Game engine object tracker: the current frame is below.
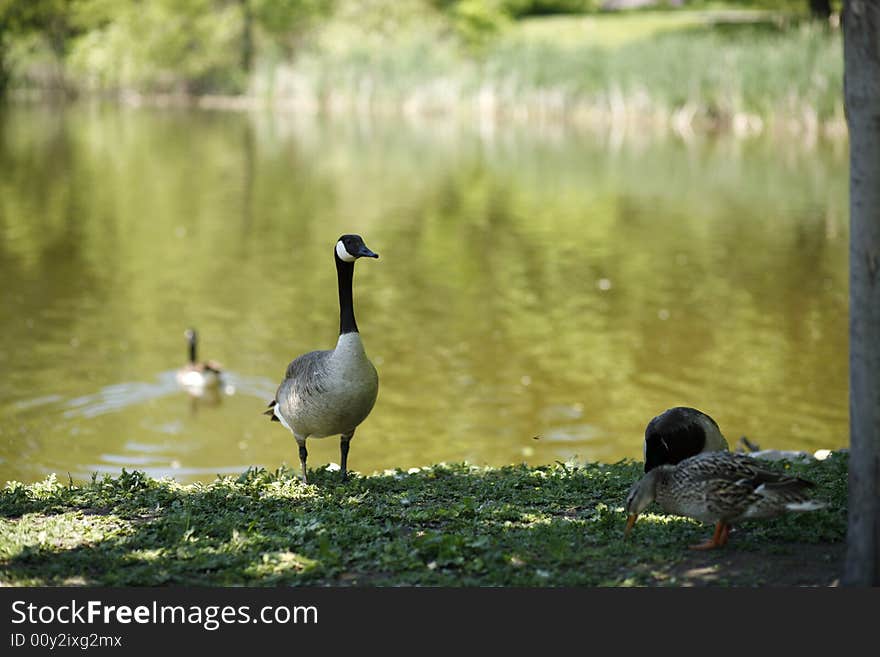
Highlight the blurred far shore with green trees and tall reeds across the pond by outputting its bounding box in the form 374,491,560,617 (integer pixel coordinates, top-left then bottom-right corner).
0,0,843,132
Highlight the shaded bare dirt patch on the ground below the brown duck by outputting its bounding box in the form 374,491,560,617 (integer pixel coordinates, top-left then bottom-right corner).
655,543,846,586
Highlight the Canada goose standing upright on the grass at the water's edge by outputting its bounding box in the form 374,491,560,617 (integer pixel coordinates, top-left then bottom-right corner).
265,235,379,483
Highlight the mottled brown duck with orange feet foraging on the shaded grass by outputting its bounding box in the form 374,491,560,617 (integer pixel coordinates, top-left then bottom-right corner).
625,452,825,550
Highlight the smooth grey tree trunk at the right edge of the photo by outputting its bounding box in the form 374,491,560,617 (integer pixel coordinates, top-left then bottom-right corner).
842,0,880,586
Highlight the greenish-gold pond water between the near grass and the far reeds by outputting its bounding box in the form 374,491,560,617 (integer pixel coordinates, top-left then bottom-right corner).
0,104,848,483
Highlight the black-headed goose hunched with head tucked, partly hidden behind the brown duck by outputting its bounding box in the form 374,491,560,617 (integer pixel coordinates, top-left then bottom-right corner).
644,406,728,472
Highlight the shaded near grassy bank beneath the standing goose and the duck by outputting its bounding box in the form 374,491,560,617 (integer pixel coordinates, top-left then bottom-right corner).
0,455,847,586
